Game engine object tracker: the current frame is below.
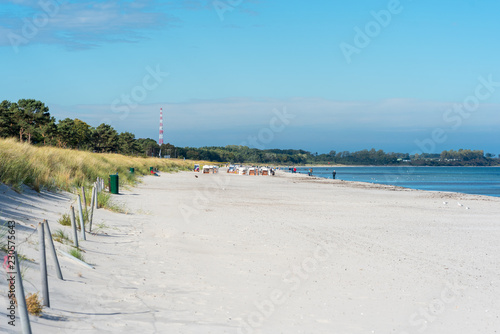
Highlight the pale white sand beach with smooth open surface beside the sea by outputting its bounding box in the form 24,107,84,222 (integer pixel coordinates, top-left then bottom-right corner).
0,169,500,334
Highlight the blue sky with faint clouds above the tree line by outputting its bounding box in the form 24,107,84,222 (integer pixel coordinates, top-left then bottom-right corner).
0,0,500,154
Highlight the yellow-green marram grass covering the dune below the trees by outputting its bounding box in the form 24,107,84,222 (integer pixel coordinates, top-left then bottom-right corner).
0,138,193,191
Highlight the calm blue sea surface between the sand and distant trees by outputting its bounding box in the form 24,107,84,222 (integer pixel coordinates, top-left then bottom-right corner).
288,167,500,197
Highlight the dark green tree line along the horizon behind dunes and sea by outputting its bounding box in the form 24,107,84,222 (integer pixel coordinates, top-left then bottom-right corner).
0,99,500,166
